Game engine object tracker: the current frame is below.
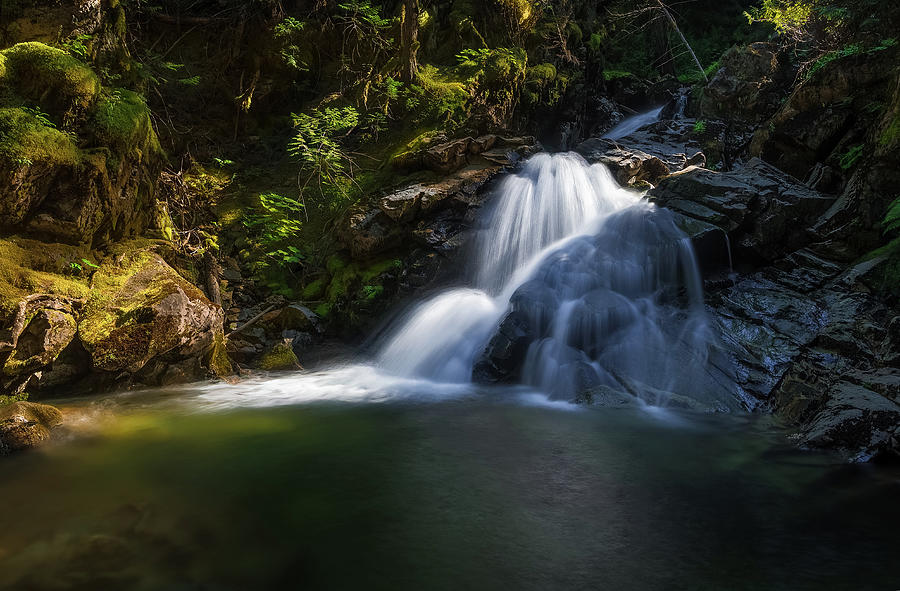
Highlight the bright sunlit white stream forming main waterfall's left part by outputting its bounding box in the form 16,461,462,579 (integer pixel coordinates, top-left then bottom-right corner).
377,153,641,382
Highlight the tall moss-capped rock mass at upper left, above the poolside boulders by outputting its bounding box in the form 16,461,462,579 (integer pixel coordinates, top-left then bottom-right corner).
0,43,164,246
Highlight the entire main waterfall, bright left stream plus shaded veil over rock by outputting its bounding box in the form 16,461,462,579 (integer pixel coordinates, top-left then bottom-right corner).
376,147,735,408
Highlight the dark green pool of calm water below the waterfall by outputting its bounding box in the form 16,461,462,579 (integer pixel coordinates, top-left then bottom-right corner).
0,393,900,591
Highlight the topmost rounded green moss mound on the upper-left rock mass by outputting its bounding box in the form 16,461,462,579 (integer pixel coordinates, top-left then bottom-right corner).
0,42,101,125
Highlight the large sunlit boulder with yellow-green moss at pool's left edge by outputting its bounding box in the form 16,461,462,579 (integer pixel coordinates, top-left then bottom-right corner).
78,249,230,383
